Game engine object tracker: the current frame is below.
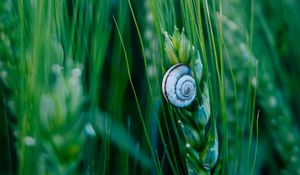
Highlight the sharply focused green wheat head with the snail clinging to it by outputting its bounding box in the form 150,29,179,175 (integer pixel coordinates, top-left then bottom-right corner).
164,28,219,174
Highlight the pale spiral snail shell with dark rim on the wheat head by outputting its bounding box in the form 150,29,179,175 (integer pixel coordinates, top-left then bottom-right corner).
162,64,196,107
